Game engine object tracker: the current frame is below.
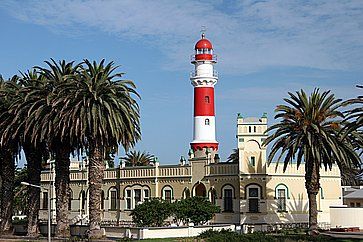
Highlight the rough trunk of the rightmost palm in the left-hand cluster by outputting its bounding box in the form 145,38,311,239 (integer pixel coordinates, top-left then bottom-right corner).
88,144,105,239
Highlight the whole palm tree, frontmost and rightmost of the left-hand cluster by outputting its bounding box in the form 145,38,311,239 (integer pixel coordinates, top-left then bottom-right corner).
57,60,140,238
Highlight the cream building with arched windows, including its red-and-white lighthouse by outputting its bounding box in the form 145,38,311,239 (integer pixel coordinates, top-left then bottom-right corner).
40,34,342,229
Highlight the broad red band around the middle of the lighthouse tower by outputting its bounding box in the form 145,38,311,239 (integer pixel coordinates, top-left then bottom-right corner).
194,87,214,117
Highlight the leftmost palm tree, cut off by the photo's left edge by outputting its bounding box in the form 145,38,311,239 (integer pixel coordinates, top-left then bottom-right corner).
0,75,19,233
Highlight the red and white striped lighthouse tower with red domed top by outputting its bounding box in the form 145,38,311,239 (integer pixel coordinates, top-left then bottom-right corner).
190,33,218,152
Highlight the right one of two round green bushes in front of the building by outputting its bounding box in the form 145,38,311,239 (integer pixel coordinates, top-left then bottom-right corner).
173,197,220,224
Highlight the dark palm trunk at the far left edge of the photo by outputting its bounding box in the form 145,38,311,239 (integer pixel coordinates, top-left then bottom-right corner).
0,147,15,234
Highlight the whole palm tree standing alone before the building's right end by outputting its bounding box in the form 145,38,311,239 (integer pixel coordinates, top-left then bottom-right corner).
264,89,360,233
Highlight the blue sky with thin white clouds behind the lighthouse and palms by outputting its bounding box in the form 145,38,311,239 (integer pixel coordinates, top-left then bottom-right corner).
0,0,363,164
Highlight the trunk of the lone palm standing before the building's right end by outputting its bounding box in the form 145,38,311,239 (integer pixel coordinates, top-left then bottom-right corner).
305,162,320,235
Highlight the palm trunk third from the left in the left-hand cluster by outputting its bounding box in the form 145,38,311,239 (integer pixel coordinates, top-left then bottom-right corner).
54,144,71,238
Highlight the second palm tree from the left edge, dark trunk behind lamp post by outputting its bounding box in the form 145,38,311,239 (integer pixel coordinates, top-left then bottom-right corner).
4,70,48,236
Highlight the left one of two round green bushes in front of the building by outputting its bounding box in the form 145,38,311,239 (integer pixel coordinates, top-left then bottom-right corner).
131,198,172,227
